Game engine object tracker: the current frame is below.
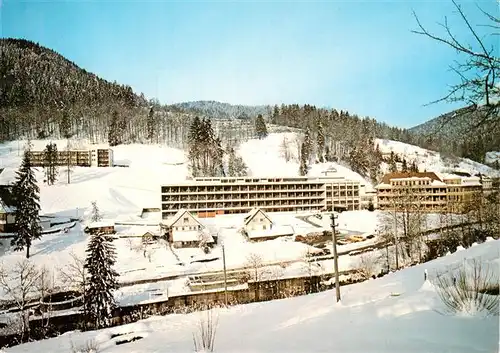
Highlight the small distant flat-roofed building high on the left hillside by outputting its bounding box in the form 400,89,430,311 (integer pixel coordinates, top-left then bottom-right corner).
31,148,113,167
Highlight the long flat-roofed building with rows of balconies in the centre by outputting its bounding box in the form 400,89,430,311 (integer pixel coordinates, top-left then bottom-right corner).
161,177,360,219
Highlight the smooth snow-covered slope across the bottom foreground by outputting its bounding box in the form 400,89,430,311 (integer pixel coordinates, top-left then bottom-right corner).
6,240,500,353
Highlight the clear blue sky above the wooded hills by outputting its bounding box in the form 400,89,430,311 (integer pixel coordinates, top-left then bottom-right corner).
0,0,499,127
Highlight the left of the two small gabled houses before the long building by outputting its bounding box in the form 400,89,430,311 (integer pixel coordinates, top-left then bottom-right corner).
161,209,214,248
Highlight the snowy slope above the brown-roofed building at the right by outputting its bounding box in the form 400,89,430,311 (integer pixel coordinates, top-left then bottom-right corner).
375,139,500,177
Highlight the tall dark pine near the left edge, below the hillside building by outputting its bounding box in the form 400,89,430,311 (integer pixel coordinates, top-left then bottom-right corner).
11,144,42,258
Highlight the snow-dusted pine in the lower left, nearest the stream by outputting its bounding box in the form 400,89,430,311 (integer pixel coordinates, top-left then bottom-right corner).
84,233,118,329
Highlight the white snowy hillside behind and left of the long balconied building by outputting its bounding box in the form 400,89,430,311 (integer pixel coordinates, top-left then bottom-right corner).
0,133,366,218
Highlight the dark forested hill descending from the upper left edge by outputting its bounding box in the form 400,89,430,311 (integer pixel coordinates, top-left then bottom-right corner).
0,38,200,145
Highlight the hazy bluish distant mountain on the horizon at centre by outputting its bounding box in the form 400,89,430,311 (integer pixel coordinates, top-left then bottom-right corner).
172,101,272,119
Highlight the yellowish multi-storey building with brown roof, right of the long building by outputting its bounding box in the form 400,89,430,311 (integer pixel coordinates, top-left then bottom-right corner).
376,172,483,212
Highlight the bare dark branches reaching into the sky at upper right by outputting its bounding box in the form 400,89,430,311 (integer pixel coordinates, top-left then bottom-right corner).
413,0,500,127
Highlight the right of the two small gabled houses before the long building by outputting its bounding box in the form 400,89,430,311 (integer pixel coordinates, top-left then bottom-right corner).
242,208,294,241
